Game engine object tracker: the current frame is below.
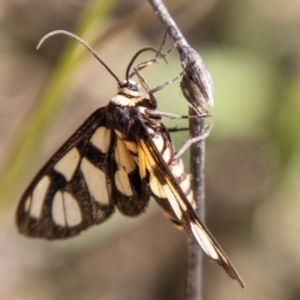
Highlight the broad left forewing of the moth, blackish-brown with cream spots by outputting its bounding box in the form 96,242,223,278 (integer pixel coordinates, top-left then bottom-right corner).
16,108,114,239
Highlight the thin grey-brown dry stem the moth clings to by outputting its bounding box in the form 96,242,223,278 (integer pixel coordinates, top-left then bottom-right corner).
149,0,209,300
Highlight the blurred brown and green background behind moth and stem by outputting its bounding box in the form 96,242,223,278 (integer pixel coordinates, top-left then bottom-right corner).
0,0,300,300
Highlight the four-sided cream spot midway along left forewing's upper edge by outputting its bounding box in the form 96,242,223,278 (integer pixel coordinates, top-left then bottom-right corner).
54,148,80,181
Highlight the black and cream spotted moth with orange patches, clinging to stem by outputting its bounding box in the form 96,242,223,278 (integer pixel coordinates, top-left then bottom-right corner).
16,31,245,287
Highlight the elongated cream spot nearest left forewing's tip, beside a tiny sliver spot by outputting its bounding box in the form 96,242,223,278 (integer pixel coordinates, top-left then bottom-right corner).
29,176,50,219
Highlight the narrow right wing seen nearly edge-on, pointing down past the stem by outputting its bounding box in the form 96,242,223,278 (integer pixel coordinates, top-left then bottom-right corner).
135,122,245,287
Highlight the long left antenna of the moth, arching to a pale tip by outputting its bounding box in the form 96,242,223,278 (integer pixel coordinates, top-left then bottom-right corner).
36,30,124,86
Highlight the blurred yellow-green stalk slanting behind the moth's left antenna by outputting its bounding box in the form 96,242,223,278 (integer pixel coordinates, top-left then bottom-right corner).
0,0,113,210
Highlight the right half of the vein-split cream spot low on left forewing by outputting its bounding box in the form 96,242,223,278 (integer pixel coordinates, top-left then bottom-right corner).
63,192,82,227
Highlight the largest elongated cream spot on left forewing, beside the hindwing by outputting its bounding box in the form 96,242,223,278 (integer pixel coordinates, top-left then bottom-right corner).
80,158,109,205
